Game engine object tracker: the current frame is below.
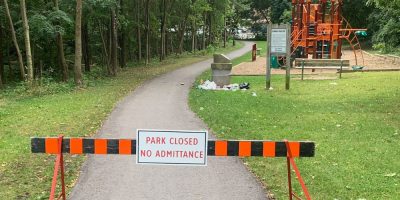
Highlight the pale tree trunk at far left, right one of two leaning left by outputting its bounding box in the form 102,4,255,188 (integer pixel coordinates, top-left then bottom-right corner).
20,0,33,83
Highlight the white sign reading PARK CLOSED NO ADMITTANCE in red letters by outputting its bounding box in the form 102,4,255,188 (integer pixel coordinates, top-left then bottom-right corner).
136,130,208,166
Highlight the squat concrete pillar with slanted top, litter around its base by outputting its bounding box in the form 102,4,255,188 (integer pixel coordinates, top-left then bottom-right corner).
211,54,232,87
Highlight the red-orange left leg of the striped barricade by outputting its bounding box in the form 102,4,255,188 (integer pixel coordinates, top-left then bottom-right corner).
49,135,66,200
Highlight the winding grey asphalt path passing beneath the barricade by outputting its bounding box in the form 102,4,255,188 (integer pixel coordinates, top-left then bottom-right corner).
69,42,266,200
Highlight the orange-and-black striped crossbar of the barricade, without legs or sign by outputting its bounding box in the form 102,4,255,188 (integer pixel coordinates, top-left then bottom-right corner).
31,138,315,157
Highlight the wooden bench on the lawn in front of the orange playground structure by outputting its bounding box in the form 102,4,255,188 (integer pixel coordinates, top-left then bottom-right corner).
295,58,350,80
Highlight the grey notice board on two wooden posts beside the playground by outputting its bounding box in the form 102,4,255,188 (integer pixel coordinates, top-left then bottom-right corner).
265,24,291,90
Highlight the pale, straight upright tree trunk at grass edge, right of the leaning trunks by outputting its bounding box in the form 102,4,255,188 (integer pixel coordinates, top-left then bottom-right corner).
74,0,82,86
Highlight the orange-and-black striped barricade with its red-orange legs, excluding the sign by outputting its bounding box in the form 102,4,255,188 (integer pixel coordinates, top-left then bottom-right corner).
31,136,315,200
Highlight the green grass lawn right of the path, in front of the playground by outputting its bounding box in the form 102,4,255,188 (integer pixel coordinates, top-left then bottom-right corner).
190,59,400,199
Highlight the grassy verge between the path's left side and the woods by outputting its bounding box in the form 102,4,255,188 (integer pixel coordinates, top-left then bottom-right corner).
0,43,242,199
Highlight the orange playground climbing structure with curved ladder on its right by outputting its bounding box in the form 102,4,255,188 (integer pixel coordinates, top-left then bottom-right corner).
291,0,366,65
